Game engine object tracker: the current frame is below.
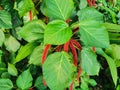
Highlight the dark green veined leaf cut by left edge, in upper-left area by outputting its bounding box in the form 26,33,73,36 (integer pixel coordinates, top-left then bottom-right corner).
0,10,12,29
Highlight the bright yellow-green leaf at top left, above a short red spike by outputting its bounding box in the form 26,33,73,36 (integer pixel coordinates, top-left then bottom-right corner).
16,0,34,17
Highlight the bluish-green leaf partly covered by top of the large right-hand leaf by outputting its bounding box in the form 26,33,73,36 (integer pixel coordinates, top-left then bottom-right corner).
77,7,103,22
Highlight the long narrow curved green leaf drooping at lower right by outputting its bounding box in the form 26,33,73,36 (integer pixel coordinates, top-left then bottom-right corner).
97,48,118,85
